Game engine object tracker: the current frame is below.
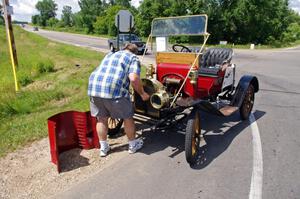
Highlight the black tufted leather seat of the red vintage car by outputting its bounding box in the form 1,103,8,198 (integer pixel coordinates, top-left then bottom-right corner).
200,48,233,68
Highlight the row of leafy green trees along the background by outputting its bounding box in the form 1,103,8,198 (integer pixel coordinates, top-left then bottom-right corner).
32,0,300,44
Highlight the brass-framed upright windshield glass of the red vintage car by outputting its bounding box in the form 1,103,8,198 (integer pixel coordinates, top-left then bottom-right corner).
151,15,207,37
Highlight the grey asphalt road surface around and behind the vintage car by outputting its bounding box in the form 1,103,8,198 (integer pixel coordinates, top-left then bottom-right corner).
25,26,300,199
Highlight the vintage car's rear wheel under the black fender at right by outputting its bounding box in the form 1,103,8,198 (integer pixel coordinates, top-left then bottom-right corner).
240,84,254,120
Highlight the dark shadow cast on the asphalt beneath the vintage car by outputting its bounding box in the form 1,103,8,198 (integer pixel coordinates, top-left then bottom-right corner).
134,111,266,169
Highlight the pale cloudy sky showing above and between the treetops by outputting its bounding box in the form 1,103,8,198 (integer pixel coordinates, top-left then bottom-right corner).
3,0,300,22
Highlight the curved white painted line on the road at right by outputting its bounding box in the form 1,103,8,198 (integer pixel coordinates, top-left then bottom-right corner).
249,113,263,199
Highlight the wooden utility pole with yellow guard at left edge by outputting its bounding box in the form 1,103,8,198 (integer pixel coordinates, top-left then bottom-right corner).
2,0,19,92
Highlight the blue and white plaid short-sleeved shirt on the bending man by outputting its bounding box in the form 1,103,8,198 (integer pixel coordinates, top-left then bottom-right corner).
88,50,141,99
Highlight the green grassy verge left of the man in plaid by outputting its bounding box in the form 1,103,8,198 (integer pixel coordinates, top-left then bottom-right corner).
0,26,103,157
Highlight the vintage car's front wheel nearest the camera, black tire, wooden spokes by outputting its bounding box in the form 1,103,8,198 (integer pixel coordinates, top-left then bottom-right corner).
185,109,201,165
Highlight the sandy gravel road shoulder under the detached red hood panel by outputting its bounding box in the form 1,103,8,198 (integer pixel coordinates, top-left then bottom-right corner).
0,131,128,198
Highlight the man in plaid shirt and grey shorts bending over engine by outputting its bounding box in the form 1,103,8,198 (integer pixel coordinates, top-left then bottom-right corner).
88,43,149,157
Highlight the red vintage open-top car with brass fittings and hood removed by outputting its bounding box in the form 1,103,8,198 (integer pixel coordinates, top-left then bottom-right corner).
110,15,259,164
